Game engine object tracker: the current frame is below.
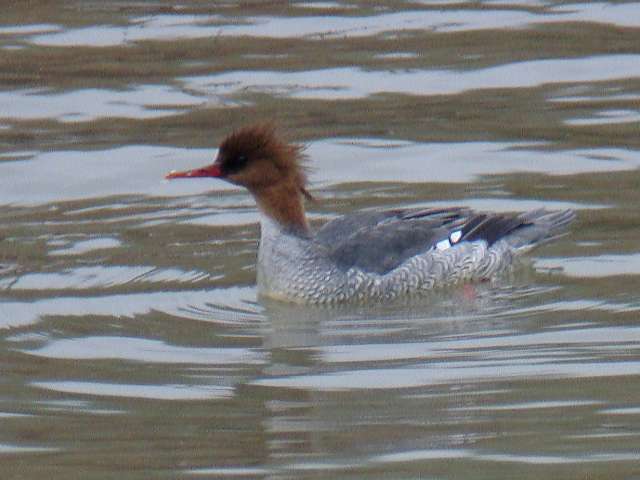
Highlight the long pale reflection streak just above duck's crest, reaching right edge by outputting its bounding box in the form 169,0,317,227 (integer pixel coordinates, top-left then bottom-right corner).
182,55,640,99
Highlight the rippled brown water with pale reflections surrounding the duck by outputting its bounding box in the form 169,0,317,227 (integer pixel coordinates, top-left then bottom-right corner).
0,0,640,480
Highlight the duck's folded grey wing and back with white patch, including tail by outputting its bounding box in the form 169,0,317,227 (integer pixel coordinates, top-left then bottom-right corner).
316,207,575,274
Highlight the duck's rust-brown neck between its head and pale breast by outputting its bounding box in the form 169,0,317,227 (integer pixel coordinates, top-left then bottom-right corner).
253,182,310,237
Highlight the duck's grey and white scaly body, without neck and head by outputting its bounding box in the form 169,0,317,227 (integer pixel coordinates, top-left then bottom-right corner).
257,208,574,304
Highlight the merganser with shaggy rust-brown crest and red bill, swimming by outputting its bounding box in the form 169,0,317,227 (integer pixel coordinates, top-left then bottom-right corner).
166,124,575,304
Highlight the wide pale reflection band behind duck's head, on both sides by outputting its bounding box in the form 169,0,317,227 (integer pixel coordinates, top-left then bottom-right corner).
0,138,640,206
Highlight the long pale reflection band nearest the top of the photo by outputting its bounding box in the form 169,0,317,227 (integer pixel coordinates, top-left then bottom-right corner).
25,1,640,47
